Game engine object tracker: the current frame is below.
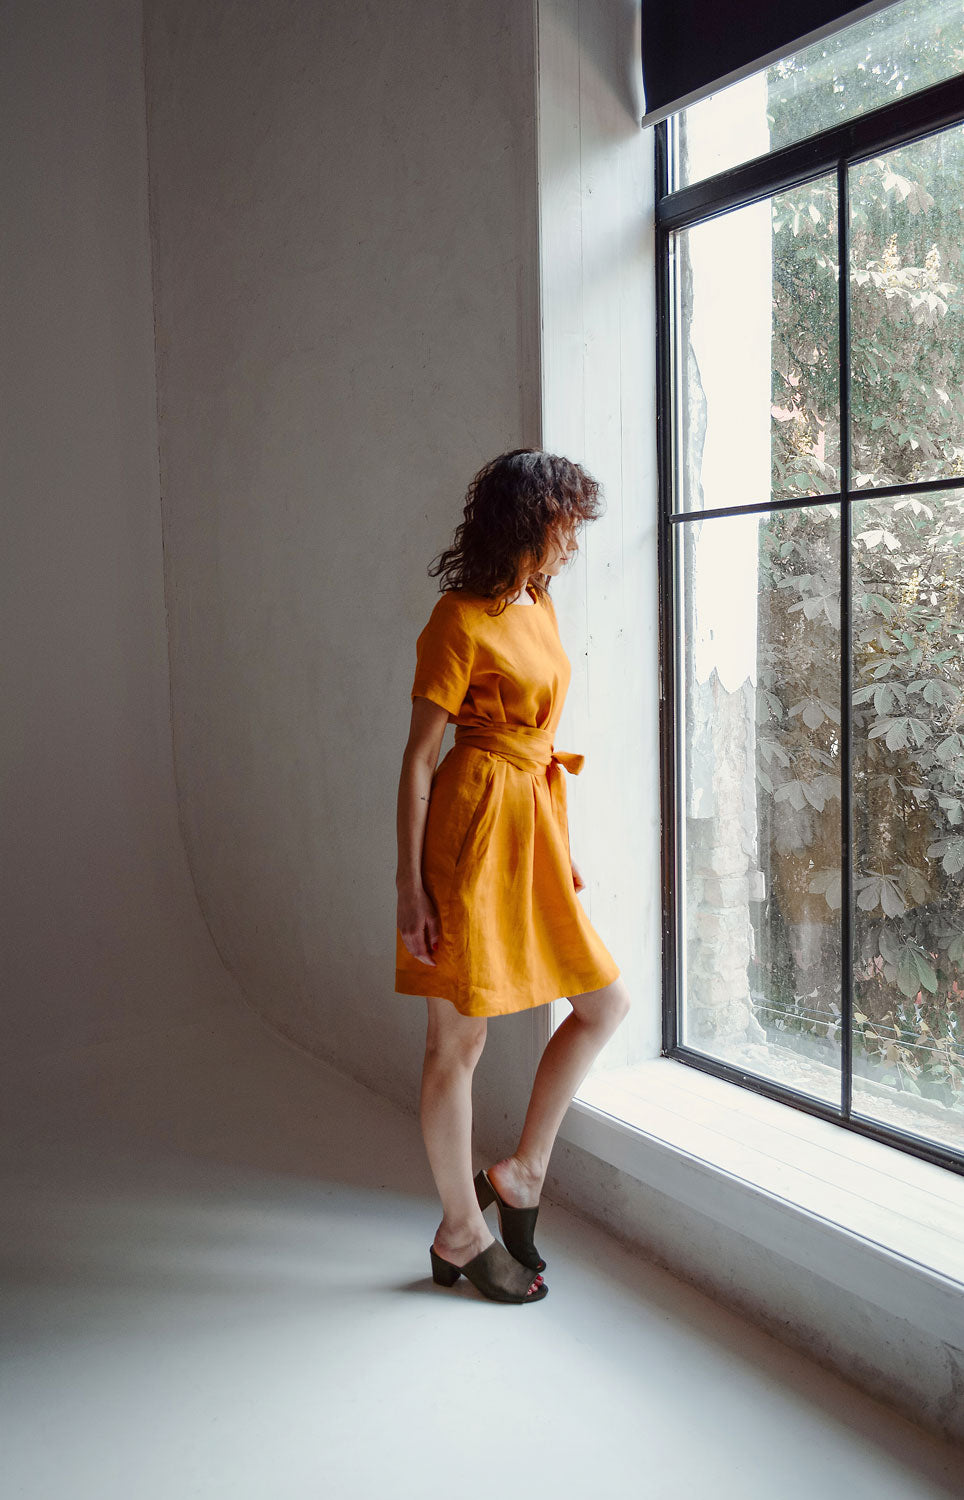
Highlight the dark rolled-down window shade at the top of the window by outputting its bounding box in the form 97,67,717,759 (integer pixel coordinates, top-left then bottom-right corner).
642,0,892,125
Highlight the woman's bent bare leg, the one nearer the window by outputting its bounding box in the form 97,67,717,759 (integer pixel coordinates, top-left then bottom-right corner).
489,980,630,1208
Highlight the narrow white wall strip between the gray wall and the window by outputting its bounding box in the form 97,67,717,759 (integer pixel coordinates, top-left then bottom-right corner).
538,0,661,1071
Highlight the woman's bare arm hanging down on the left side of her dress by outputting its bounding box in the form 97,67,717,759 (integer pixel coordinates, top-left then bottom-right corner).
394,698,448,968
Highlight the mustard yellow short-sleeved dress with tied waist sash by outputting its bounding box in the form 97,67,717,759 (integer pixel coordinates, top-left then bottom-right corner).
396,590,619,1016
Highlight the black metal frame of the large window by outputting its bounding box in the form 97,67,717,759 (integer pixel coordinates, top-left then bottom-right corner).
655,74,964,1176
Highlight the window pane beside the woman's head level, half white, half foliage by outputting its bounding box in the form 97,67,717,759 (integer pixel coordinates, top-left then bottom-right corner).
675,176,840,512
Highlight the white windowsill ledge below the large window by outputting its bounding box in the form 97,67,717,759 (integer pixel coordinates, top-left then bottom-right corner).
561,1058,964,1344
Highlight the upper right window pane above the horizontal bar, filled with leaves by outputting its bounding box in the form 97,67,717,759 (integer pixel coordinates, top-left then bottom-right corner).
850,126,964,488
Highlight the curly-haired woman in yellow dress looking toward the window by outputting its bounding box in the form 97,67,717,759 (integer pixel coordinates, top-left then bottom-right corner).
396,449,630,1304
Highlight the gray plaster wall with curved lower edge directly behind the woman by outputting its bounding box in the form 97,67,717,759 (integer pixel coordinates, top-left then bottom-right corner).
145,0,538,1131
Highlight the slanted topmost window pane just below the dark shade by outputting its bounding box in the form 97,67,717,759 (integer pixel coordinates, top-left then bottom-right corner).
670,0,964,188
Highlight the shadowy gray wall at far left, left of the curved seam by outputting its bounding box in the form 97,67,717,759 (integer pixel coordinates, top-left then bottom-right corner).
0,0,229,1086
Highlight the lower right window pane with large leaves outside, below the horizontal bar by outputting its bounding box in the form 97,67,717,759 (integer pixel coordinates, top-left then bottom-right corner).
853,491,964,1151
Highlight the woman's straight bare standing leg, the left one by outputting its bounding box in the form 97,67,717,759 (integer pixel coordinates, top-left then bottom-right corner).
418,996,543,1286
